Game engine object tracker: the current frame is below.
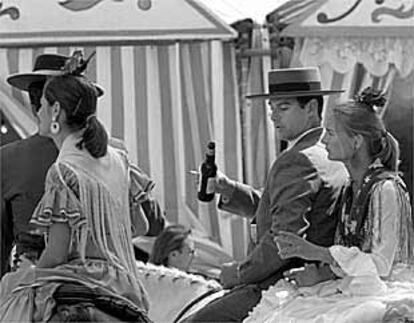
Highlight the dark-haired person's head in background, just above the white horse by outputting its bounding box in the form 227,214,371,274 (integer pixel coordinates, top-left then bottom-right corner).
149,224,195,271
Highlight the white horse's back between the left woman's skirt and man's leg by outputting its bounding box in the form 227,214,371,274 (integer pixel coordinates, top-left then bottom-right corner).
136,261,226,323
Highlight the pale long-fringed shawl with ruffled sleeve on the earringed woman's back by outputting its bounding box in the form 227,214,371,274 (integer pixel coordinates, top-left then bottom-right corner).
32,134,143,286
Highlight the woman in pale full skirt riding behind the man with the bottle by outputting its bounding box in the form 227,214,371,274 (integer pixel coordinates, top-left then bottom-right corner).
246,88,414,322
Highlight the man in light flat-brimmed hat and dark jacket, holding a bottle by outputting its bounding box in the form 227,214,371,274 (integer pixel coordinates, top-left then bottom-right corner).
186,68,347,322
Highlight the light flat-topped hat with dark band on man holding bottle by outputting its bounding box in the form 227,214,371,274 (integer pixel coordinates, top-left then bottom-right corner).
247,67,344,99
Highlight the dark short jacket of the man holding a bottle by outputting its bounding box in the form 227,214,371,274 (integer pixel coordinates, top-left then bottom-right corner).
219,128,348,288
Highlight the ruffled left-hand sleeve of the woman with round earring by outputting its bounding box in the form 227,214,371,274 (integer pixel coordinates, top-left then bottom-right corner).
30,163,86,231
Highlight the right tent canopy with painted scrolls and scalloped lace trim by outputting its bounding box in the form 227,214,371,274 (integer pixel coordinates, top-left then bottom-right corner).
272,0,414,77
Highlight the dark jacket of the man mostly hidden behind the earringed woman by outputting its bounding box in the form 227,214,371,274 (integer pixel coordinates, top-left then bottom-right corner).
0,135,58,276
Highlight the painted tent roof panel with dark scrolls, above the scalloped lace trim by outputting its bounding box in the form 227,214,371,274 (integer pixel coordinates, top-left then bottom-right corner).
284,0,414,37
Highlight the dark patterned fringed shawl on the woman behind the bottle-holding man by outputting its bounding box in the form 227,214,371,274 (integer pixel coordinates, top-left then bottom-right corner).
335,163,414,264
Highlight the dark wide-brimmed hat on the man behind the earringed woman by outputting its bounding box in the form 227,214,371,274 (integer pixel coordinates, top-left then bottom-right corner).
7,54,104,96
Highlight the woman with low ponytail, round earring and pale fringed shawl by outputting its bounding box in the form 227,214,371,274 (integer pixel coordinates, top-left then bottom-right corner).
0,52,149,322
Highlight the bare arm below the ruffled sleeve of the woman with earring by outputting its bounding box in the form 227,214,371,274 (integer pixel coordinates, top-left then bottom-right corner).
37,222,71,268
